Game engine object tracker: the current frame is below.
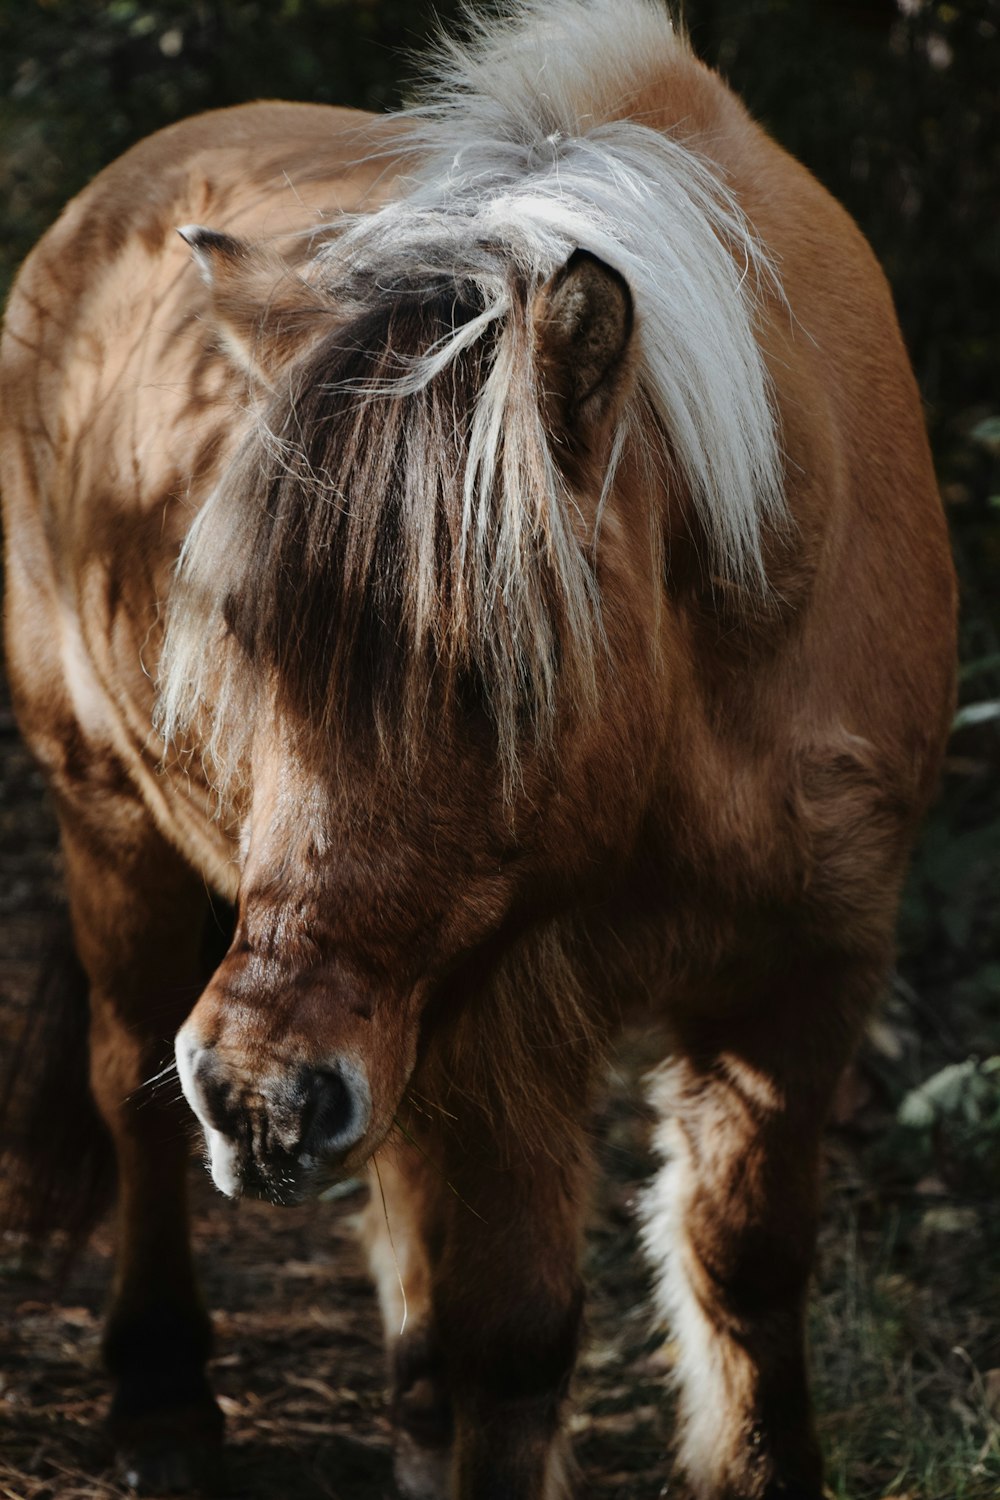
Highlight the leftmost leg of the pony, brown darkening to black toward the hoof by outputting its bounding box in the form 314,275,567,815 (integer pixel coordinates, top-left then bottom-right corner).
60,798,222,1494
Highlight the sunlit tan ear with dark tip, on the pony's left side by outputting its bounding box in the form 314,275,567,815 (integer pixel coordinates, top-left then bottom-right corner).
177,224,333,387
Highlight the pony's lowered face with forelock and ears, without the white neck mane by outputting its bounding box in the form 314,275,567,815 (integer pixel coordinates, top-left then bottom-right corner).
168,231,660,1202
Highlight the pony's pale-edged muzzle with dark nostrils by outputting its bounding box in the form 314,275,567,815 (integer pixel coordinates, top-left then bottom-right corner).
177,1028,372,1205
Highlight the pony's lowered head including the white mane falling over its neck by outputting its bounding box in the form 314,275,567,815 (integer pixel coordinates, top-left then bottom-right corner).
160,67,780,1200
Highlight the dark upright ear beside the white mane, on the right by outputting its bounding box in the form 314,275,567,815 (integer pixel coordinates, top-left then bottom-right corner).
532,251,634,447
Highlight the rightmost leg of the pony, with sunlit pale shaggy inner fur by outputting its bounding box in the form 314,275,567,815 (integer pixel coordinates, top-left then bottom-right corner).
645,975,873,1500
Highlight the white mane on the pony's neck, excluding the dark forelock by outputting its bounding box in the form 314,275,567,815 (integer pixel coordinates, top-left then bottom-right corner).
338,0,784,585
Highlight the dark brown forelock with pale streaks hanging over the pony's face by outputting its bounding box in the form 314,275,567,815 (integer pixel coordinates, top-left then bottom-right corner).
223,278,587,762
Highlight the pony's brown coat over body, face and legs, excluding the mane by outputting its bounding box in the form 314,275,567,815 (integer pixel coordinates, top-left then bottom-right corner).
0,5,955,1500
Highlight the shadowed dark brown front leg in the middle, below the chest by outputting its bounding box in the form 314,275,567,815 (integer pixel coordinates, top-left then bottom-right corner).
433,1116,591,1500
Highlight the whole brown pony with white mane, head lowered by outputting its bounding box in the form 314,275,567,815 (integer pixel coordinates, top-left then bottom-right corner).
1,0,955,1500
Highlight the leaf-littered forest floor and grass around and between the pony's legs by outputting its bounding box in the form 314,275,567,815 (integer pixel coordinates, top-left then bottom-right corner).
0,675,1000,1500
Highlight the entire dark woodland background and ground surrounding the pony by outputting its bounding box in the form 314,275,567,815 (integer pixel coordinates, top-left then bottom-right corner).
0,0,1000,1500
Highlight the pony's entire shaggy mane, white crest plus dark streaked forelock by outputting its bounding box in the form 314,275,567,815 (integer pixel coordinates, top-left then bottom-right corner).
159,0,783,788
